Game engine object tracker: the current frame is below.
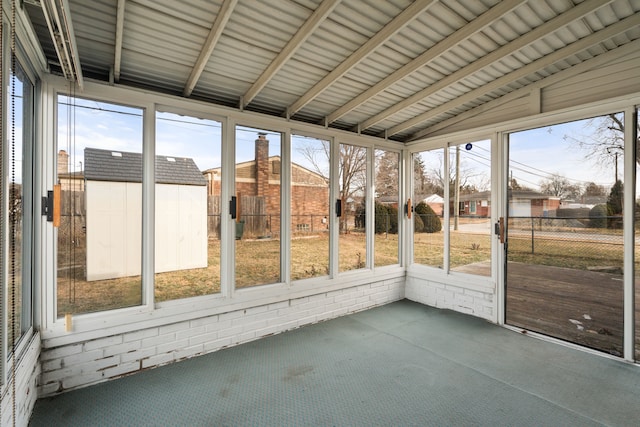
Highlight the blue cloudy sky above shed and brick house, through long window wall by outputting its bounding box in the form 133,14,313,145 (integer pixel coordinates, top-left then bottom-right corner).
58,97,318,176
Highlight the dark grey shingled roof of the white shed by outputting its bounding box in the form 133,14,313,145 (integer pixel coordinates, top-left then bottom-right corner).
84,148,207,185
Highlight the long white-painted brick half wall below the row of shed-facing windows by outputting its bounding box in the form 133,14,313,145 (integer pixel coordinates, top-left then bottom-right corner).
38,277,405,397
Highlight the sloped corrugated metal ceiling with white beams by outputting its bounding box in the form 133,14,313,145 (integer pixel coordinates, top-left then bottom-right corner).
23,0,640,141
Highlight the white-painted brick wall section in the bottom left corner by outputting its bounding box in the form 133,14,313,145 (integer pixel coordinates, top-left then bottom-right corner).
0,333,40,426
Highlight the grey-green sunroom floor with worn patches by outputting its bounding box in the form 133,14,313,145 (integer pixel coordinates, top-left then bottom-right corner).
31,300,640,426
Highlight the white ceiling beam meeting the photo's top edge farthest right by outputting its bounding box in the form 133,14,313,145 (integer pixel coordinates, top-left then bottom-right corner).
361,0,611,134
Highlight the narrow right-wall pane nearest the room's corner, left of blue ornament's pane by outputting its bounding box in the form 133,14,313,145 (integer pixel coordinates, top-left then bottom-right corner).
413,149,448,268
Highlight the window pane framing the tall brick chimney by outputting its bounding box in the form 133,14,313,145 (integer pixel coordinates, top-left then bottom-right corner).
235,126,282,288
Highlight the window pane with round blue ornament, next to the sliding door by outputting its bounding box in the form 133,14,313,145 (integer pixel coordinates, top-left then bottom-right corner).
449,141,492,276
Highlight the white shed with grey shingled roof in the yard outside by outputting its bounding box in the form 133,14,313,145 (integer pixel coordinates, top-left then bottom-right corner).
84,148,207,281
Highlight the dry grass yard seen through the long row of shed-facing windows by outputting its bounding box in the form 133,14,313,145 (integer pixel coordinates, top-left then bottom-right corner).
57,232,398,317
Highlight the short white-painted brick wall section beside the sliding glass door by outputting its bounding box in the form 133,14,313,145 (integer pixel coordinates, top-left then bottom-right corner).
405,275,497,322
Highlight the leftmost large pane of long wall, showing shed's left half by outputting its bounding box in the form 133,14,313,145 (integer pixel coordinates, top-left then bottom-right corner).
57,95,142,317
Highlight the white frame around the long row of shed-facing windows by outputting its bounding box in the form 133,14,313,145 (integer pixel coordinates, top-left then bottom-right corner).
39,75,404,345
